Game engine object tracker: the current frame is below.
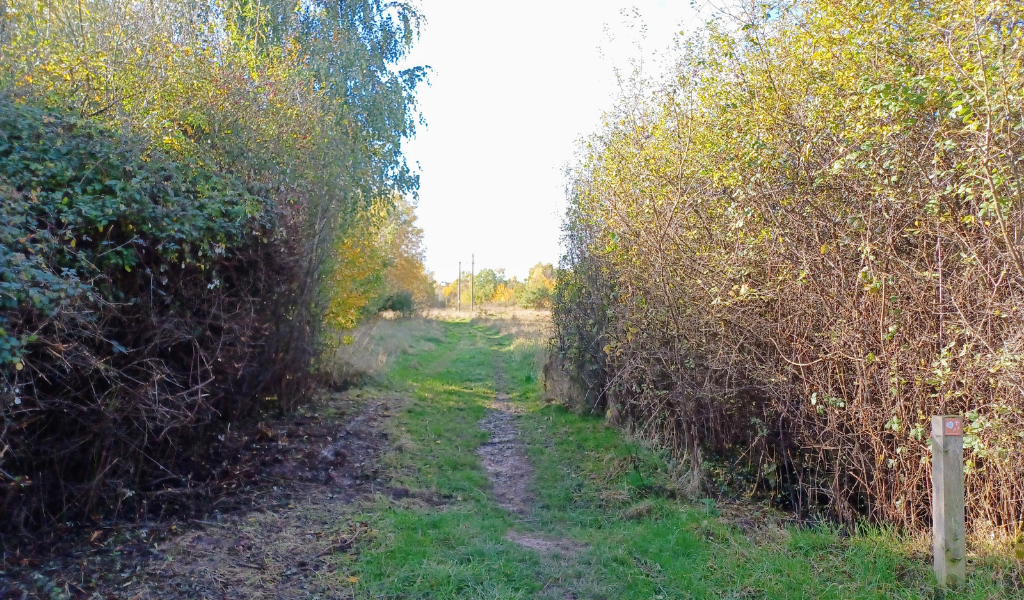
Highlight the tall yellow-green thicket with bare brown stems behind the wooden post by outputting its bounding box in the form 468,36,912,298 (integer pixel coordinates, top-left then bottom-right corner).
554,0,1024,531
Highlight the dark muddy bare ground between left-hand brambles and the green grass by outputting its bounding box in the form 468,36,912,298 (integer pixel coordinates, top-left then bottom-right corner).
0,393,399,600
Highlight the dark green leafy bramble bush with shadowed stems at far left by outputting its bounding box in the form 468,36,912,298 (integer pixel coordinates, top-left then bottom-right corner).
0,99,290,526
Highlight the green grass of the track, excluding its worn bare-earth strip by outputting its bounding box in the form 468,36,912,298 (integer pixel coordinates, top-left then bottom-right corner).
339,315,1021,599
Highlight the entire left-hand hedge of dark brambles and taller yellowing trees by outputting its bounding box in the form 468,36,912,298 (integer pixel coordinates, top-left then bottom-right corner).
0,0,426,531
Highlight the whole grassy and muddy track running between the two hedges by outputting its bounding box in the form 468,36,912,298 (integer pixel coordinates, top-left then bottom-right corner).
6,318,1024,600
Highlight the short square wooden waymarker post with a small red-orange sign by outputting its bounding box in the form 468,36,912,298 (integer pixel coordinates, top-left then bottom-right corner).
932,415,967,587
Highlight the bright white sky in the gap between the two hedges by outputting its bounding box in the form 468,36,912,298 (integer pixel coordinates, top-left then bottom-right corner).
407,0,697,282
